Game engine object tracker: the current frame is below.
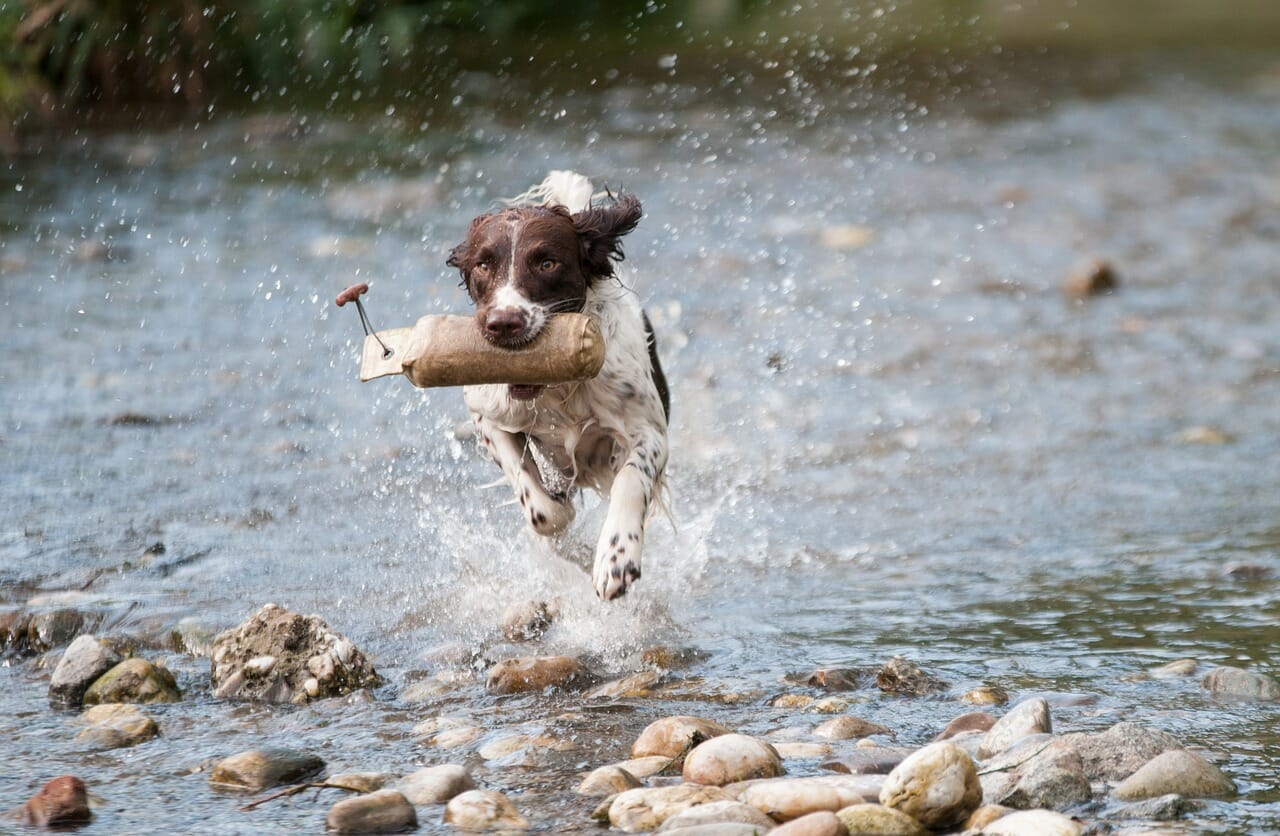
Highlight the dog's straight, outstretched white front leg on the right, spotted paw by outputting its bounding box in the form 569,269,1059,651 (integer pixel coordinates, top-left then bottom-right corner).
591,431,667,600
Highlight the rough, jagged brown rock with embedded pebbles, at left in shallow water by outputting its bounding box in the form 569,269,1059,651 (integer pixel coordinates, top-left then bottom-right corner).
210,604,381,703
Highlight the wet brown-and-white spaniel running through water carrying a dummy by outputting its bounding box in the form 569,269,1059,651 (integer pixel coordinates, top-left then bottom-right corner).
447,172,671,600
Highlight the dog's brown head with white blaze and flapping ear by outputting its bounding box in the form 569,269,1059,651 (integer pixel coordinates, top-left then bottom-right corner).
448,195,641,348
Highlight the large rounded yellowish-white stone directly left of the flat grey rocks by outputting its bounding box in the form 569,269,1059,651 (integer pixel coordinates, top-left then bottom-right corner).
879,743,982,830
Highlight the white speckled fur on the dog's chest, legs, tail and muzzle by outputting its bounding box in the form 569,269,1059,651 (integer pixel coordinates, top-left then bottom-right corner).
463,172,667,600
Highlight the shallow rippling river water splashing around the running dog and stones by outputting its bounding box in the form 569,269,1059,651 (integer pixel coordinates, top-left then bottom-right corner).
0,44,1280,833
